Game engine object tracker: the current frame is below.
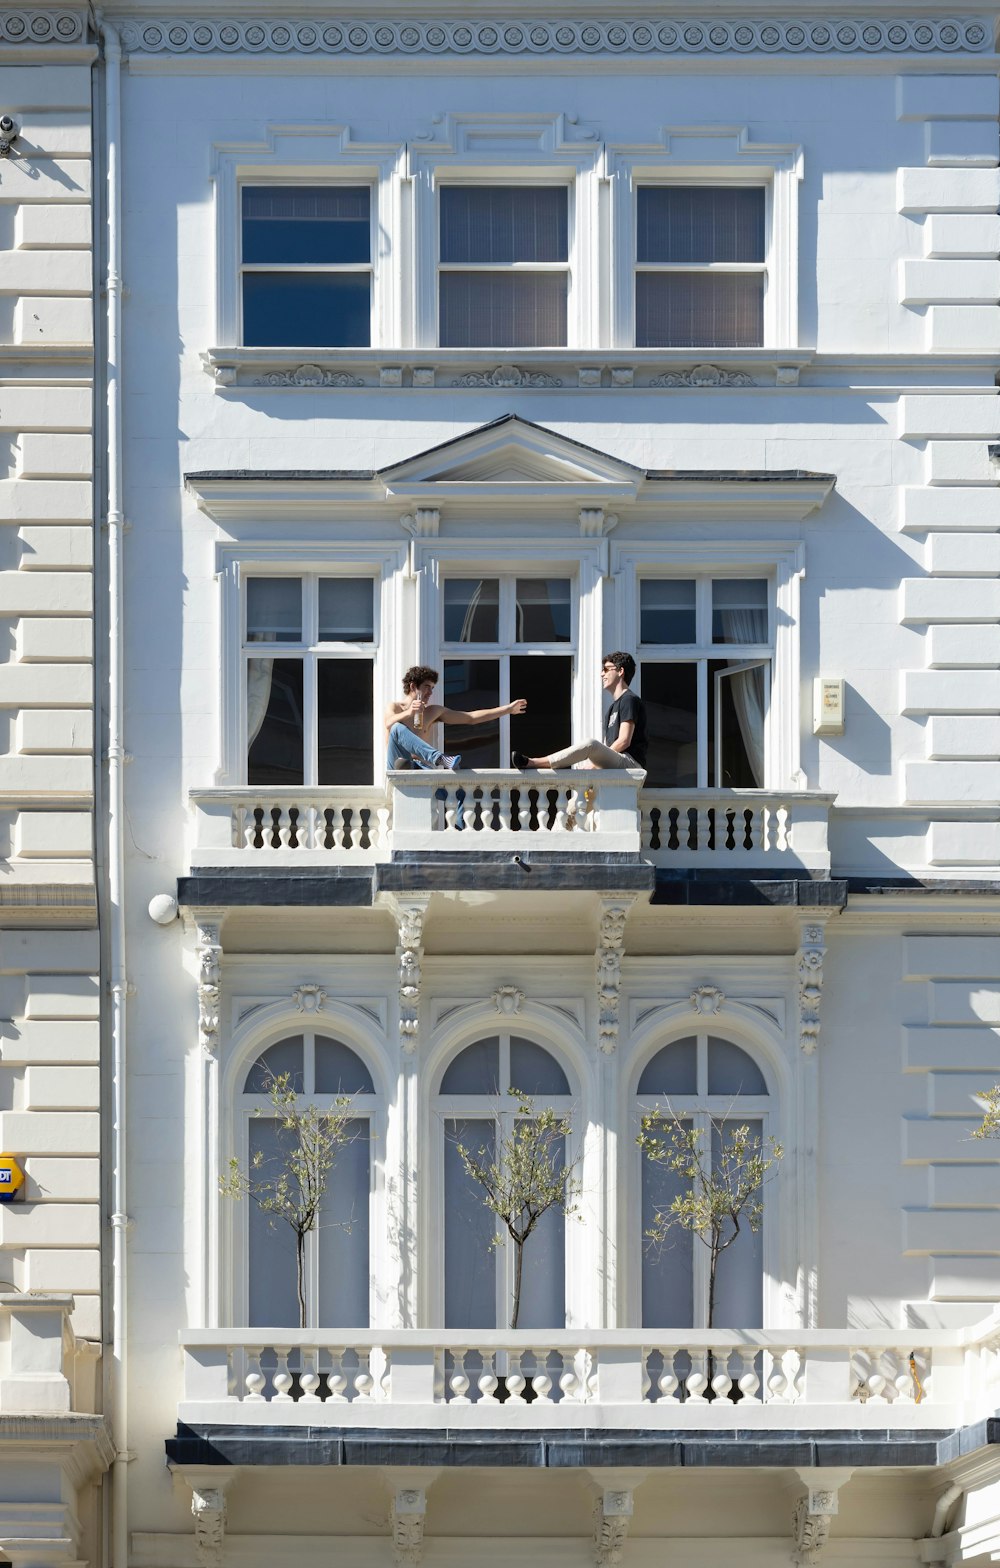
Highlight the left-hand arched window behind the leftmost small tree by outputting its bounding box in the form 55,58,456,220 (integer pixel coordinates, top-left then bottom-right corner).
238,1032,376,1328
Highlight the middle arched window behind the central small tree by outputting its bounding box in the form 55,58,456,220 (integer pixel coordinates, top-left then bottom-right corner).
436,1035,572,1328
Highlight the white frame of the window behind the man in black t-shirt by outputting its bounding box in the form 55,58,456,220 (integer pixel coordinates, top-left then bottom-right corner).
608,539,806,792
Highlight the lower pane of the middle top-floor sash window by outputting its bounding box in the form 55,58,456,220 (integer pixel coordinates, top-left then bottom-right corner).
442,273,569,348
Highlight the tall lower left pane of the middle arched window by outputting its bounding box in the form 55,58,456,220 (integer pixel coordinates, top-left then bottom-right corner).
445,1118,497,1328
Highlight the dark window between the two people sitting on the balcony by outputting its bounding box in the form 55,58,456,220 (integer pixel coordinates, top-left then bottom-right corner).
442,577,575,768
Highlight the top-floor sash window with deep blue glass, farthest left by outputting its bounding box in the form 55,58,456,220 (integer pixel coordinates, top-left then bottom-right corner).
240,185,371,348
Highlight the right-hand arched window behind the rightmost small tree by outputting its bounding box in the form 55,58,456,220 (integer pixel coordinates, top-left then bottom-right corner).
638,1033,773,1328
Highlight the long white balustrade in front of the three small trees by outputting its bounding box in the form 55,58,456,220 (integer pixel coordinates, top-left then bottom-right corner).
179,1312,1000,1430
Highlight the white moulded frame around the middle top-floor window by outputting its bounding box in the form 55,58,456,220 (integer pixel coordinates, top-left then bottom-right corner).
409,114,602,356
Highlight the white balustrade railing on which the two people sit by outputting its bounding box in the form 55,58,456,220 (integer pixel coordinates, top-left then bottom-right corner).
191,770,834,875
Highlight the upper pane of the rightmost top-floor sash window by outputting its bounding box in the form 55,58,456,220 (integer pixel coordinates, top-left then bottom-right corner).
636,185,765,263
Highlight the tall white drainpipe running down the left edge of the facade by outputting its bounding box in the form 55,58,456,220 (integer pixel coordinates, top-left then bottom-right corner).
100,19,132,1568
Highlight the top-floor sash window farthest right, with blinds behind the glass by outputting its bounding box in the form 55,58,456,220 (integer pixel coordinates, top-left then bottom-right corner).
635,185,766,348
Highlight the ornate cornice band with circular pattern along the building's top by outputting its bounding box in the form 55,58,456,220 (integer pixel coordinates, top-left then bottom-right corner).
119,13,994,58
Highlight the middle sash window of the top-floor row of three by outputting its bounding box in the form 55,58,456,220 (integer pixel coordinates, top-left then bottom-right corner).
437,185,569,348
